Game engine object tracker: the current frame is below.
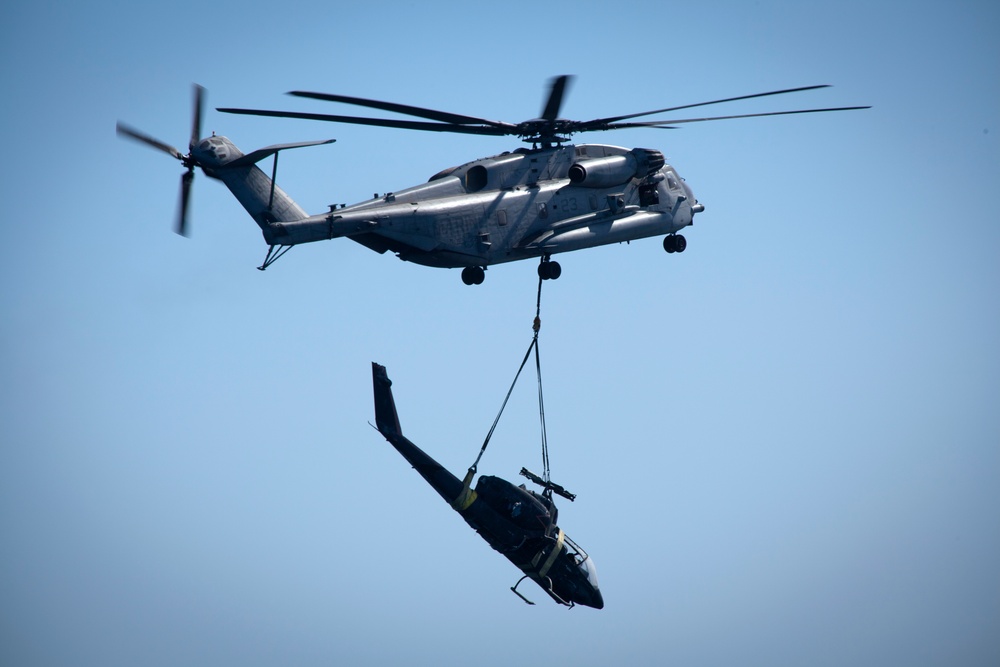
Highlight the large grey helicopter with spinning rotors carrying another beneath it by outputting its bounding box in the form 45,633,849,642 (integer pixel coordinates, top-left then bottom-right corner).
117,76,869,285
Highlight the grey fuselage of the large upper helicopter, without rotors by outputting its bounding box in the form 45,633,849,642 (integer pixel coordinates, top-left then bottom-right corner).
201,137,703,268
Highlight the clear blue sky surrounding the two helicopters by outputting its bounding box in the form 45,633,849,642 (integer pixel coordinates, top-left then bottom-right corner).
0,0,1000,667
